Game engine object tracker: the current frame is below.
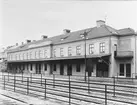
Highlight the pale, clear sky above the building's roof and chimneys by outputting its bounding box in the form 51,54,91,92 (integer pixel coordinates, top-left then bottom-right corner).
0,0,137,48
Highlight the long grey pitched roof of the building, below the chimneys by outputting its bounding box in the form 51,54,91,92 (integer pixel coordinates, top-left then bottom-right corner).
10,25,135,52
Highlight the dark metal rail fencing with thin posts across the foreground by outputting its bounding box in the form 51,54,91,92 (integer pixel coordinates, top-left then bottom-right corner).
3,75,137,105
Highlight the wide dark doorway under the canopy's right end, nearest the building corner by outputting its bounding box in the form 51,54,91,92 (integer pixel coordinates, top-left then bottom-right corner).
96,62,108,77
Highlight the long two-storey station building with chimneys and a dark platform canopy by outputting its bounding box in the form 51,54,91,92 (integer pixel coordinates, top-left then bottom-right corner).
7,20,137,78
